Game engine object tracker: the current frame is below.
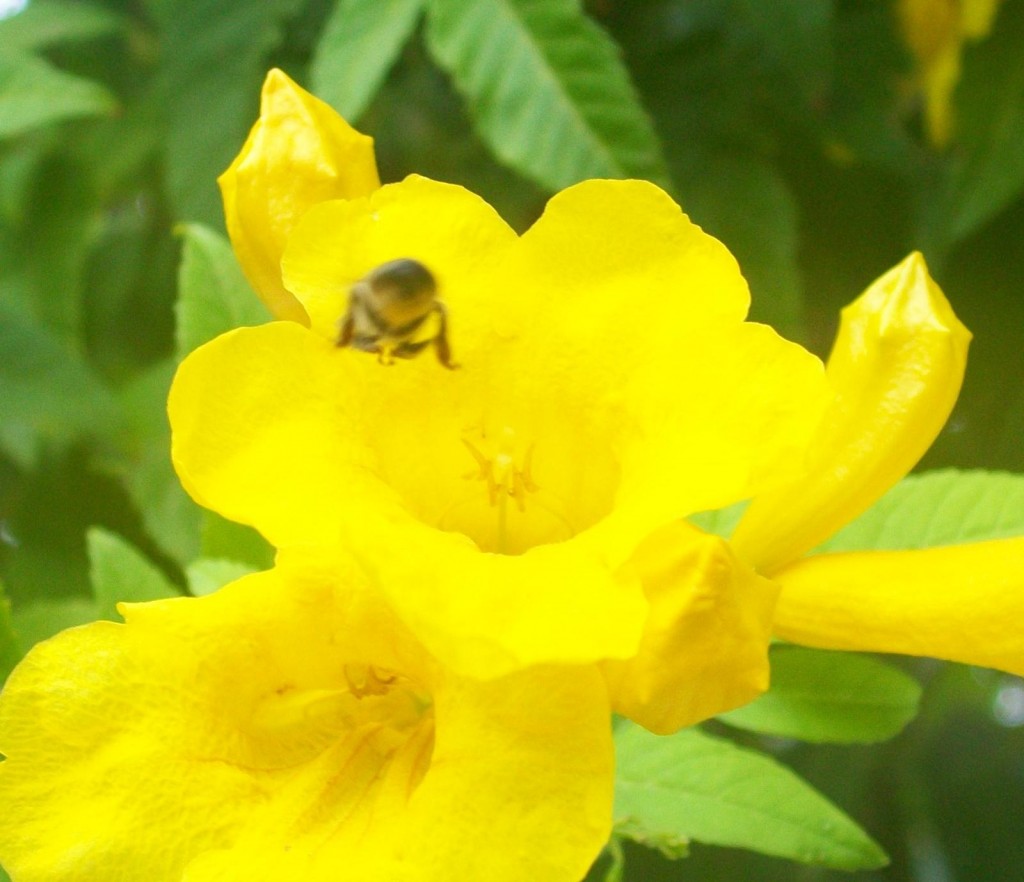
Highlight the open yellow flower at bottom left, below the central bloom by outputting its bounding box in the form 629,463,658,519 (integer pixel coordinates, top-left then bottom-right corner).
0,554,612,882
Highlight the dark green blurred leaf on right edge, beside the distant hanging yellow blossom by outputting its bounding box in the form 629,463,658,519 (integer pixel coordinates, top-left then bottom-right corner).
929,3,1024,246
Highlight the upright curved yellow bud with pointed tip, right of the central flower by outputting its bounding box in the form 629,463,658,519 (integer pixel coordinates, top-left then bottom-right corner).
732,252,971,576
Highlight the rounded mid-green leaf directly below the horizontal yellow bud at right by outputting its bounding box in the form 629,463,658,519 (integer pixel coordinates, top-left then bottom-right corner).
719,645,921,744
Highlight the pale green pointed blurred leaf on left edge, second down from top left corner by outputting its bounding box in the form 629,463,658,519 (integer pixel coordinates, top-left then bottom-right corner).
0,52,117,139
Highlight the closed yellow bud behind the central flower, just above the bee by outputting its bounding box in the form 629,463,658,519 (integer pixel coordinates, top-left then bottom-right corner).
218,70,380,324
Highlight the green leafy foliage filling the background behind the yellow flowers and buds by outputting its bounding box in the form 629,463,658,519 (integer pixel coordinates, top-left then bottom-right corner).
0,0,1024,882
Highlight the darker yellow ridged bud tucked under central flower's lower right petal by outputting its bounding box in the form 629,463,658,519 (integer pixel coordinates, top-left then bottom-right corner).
602,521,778,734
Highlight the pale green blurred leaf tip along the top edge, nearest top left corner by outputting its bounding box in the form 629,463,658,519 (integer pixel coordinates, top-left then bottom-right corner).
0,0,123,52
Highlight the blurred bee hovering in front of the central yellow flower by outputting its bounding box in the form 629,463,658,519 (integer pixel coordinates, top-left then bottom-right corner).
337,257,459,370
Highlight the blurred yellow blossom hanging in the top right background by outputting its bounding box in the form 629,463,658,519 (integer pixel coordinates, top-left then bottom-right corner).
898,0,1000,146
